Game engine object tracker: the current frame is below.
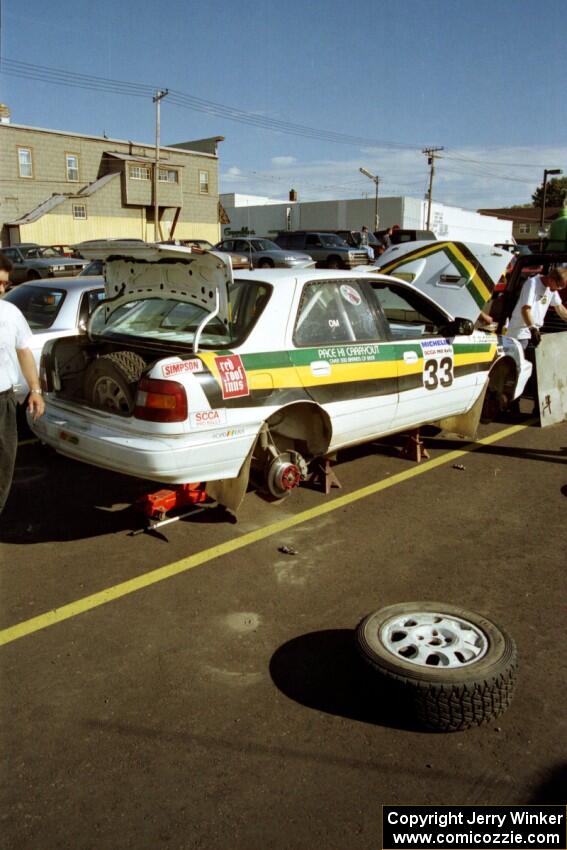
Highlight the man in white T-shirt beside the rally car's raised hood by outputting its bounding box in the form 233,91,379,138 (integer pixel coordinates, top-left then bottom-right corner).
508,268,567,348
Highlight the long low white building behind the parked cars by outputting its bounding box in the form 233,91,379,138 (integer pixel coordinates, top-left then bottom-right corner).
220,191,512,245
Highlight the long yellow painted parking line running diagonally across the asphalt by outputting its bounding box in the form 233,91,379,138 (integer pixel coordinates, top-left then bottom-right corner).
0,420,534,646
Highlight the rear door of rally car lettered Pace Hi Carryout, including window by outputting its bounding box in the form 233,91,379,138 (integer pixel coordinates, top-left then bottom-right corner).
290,278,398,448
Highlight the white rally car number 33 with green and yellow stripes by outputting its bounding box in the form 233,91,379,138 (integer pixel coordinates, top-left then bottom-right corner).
30,235,531,507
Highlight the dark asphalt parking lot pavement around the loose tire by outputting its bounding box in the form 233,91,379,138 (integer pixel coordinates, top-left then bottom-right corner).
0,410,567,850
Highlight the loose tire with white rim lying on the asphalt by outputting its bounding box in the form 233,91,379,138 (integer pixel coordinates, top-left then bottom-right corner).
356,602,518,732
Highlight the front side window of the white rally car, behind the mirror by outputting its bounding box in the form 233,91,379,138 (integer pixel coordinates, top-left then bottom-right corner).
372,283,447,340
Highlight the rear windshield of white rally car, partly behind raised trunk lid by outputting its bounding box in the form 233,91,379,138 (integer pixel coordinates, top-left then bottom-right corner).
90,281,271,348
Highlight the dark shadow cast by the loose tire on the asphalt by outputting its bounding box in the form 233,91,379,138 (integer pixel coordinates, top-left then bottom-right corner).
270,629,419,731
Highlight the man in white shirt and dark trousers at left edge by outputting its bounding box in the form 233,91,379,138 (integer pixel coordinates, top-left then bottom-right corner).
0,254,45,513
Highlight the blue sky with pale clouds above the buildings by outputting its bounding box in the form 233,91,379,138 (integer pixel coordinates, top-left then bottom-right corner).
0,0,567,209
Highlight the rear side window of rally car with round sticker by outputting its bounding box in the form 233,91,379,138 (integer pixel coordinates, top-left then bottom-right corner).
294,280,384,346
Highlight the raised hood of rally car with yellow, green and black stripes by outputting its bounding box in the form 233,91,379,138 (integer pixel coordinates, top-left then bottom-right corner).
379,241,512,322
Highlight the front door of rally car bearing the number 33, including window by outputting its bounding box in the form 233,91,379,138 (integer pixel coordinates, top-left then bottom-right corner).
372,280,490,429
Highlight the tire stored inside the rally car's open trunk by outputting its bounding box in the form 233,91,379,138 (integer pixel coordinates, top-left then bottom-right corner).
84,351,146,415
